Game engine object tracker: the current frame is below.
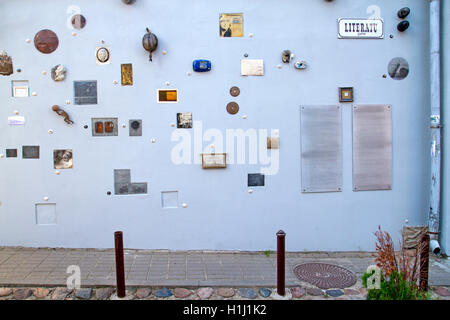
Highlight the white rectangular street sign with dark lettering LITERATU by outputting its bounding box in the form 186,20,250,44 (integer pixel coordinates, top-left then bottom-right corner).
338,19,384,39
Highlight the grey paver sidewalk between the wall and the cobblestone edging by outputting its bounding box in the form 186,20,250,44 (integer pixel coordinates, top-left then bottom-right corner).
0,247,450,287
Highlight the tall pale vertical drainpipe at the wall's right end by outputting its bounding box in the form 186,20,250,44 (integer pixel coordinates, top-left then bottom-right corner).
428,0,441,254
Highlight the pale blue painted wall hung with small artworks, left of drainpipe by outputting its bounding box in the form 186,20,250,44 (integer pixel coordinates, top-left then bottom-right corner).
0,0,429,251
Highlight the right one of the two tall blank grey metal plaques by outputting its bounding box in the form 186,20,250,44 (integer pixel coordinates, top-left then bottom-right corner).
353,105,392,191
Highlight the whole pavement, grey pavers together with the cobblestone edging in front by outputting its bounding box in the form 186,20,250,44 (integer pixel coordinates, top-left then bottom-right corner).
0,247,450,300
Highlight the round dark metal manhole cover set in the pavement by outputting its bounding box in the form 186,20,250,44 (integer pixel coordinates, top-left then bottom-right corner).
294,263,356,289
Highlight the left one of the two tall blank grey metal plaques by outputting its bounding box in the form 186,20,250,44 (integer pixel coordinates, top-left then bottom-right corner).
300,106,342,193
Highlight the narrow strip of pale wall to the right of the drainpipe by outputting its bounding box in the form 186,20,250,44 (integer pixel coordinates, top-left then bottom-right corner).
440,1,450,254
